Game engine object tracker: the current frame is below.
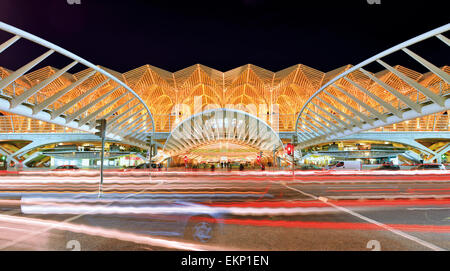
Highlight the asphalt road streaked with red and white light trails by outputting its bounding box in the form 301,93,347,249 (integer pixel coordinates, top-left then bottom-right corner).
0,172,450,251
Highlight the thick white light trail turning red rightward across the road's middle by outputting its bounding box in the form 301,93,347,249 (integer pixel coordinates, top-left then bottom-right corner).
18,197,450,216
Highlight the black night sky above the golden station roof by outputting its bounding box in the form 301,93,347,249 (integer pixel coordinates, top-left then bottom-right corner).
0,0,450,72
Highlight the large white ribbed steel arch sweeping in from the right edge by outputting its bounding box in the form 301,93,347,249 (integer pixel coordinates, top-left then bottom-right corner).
295,24,450,148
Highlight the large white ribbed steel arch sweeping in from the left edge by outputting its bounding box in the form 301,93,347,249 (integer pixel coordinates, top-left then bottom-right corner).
0,22,154,147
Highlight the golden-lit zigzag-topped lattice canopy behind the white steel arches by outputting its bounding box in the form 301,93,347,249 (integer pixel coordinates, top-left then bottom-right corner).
0,64,450,136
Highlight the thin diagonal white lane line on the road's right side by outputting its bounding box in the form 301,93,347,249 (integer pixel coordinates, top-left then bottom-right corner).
283,183,446,251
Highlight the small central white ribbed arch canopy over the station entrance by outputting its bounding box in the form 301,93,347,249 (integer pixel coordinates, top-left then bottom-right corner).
163,108,283,156
